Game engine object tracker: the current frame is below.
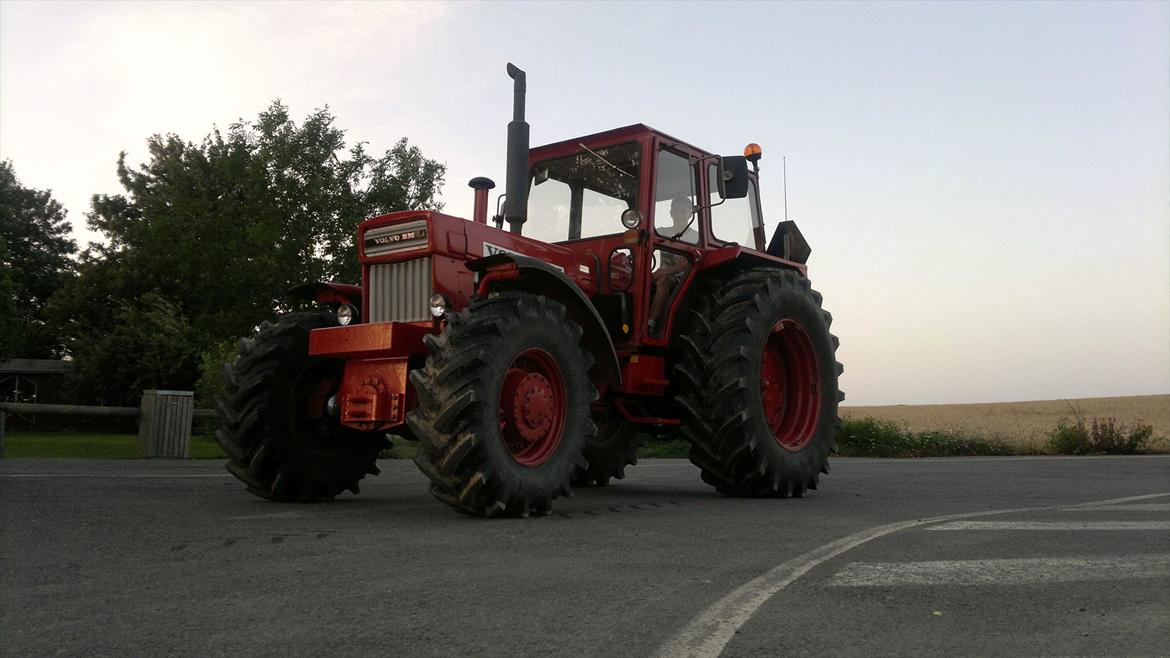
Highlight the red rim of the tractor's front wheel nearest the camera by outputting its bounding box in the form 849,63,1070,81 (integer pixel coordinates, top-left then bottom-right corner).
500,348,565,467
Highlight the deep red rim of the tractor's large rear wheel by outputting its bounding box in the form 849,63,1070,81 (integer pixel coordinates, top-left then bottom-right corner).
759,320,820,451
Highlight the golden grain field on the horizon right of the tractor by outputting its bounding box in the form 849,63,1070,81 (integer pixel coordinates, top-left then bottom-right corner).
841,395,1170,452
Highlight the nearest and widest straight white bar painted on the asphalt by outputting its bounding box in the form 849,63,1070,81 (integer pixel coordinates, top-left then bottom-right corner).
830,553,1170,587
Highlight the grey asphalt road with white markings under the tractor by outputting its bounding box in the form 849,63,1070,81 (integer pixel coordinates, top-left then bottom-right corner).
0,455,1170,657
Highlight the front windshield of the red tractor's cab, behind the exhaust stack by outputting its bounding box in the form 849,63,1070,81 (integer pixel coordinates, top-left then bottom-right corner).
524,142,642,242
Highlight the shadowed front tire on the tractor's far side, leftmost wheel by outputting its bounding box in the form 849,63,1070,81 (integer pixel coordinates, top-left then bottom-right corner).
215,313,390,501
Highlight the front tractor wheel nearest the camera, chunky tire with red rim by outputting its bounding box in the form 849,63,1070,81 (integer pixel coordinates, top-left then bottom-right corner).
407,292,597,516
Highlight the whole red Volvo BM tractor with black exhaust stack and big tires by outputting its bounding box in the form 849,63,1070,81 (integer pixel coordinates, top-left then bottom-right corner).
216,64,844,516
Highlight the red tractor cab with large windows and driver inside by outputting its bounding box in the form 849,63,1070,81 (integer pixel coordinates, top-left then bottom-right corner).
523,124,764,345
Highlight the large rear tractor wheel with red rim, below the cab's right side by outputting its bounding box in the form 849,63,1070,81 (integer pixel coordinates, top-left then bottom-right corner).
675,268,845,498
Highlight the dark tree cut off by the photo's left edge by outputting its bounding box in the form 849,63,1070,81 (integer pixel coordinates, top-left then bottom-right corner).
0,160,77,361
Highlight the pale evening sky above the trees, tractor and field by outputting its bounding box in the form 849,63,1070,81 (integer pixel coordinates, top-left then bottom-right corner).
0,0,1170,404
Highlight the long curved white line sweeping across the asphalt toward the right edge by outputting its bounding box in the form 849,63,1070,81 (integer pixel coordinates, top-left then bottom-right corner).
655,493,1170,658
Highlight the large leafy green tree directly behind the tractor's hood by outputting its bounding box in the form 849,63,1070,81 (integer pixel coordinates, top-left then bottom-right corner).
49,101,446,402
